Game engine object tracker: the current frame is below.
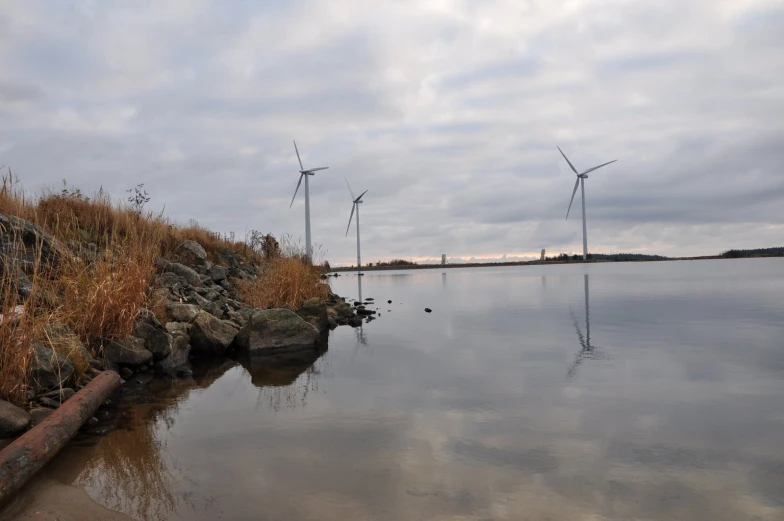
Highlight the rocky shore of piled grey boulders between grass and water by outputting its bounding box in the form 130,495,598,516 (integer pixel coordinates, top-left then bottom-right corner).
0,214,362,444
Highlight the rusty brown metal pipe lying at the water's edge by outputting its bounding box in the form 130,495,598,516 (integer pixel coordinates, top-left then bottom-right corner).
0,371,120,505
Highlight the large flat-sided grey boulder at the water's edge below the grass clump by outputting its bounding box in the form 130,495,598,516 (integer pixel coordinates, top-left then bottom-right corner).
236,309,319,356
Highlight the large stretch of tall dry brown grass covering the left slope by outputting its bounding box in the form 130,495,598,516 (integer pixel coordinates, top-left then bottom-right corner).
0,170,258,403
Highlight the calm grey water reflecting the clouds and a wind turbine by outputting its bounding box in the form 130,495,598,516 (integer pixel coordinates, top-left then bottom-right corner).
13,259,784,521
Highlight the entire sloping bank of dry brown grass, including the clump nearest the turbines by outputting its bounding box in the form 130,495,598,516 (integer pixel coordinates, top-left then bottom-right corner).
0,171,330,406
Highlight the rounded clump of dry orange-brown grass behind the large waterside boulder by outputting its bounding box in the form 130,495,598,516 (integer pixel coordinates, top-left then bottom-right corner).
238,257,330,309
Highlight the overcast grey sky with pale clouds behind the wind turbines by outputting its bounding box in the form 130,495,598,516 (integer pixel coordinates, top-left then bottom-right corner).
0,0,784,264
